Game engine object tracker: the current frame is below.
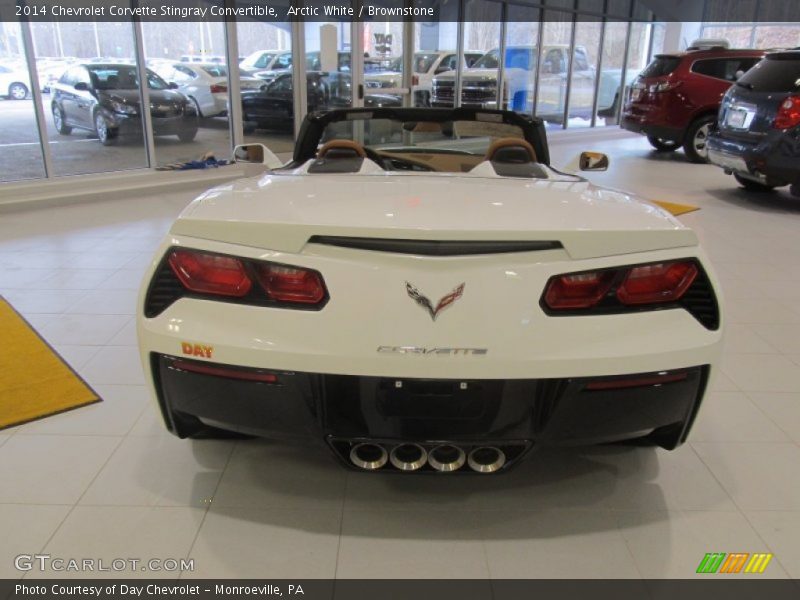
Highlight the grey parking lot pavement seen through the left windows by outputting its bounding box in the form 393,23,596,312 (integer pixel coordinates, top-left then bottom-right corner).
0,95,294,181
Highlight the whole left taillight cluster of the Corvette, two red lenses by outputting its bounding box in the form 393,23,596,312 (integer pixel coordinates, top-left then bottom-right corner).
160,248,328,312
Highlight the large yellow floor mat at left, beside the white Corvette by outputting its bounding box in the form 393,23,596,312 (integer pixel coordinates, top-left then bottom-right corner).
0,296,100,429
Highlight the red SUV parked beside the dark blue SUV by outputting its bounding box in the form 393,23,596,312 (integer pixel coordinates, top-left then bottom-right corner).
620,48,765,163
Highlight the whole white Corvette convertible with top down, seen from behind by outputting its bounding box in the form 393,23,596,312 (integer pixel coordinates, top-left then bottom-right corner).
138,108,722,473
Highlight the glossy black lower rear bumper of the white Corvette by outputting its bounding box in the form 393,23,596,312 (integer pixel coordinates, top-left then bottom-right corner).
150,353,710,462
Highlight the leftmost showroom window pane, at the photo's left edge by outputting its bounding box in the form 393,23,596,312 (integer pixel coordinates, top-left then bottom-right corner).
0,22,45,182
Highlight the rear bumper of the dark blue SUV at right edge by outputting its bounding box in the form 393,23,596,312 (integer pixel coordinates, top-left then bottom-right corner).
708,128,800,185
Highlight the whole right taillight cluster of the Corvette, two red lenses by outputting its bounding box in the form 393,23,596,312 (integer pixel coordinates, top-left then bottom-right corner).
542,260,699,312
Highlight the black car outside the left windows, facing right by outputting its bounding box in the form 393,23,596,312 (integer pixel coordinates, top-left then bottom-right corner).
51,63,197,146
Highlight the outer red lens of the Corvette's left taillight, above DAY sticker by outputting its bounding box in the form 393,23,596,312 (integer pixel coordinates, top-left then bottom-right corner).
169,250,253,298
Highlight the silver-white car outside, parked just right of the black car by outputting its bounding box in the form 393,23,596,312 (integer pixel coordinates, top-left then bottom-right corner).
158,63,266,117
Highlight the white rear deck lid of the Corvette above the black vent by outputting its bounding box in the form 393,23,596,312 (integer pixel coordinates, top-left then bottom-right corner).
171,172,697,259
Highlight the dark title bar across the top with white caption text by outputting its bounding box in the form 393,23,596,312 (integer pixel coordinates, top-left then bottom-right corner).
0,0,800,24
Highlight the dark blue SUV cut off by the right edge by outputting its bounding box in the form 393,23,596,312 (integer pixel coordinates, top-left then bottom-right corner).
708,49,800,196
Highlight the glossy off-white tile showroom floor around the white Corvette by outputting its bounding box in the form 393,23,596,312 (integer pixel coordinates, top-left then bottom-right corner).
0,132,800,578
